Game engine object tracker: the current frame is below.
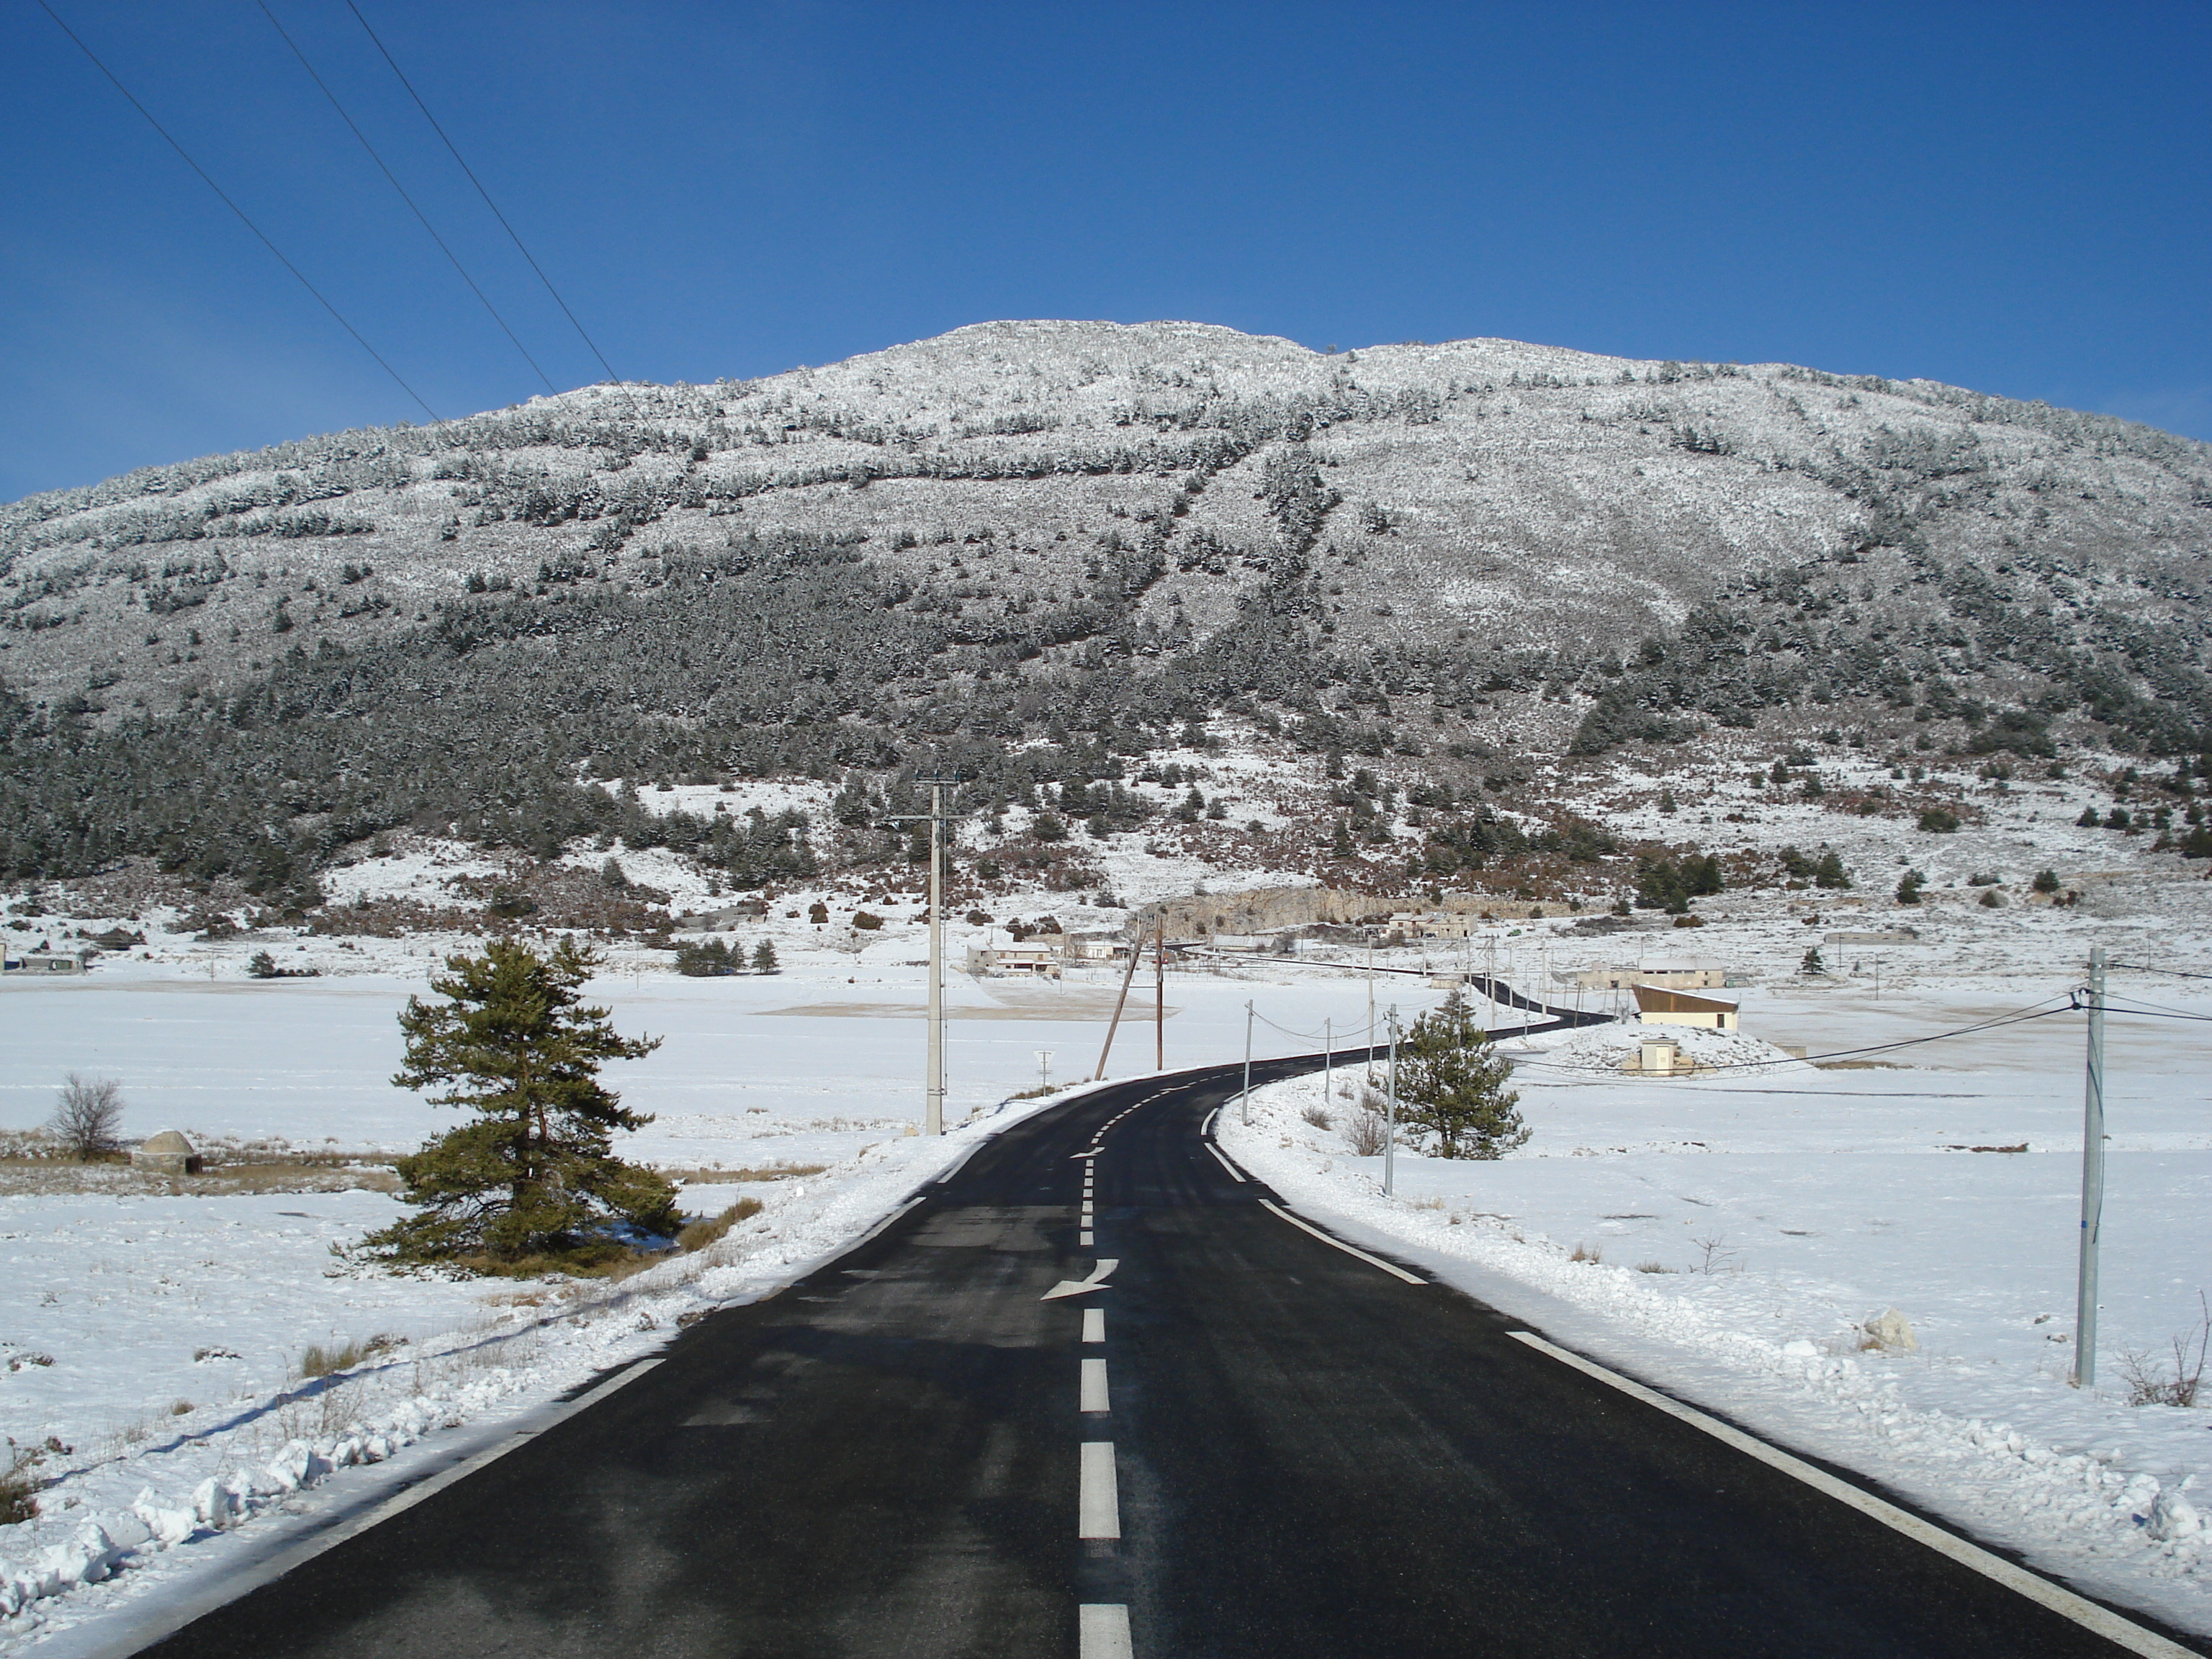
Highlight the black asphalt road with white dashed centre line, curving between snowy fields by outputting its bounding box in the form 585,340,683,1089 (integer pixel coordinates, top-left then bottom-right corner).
112,1059,2199,1659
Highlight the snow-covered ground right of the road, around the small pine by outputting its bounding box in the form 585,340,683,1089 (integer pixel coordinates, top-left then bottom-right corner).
1219,986,2212,1630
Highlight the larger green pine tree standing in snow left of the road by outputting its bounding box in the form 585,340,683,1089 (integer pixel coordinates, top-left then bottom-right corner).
367,938,677,1269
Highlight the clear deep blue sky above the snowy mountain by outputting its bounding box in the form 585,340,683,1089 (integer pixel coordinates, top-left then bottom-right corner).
0,0,2212,498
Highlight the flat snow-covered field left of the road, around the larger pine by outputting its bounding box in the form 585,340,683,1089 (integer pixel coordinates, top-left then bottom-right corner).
0,935,1389,1653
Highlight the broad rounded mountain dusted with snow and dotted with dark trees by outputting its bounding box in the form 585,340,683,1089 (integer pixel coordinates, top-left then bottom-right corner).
0,320,2212,898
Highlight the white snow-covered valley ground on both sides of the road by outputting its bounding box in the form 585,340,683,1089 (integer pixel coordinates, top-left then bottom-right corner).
0,814,2212,1650
